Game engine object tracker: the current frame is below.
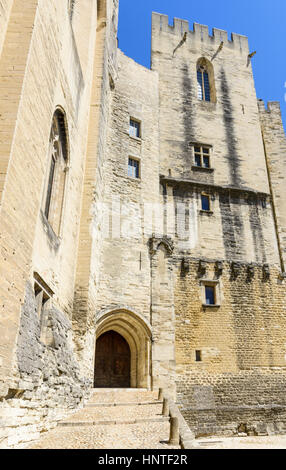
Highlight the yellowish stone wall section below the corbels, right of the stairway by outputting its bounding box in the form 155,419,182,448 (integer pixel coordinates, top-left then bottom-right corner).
175,259,286,436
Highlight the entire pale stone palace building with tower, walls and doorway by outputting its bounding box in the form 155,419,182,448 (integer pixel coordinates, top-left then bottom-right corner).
0,0,286,447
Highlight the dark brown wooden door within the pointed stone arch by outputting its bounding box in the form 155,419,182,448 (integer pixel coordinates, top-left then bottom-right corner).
94,330,131,388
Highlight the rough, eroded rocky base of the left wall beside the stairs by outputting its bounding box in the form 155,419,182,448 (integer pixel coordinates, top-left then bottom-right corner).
0,284,91,449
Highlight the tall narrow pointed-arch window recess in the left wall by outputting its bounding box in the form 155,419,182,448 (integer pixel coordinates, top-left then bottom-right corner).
43,109,68,235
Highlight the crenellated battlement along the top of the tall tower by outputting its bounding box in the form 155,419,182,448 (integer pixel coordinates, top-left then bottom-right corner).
152,12,249,52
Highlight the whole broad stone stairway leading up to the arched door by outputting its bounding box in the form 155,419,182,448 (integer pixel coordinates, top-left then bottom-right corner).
24,389,180,449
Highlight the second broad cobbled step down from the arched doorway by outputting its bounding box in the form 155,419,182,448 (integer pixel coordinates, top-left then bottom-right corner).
61,402,162,425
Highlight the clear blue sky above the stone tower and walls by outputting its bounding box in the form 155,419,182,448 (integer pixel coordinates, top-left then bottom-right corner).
118,0,286,128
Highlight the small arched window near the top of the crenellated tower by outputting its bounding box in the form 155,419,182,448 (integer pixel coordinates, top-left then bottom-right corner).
197,58,216,102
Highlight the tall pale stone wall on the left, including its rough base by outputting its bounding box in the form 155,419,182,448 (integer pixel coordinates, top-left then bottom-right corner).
0,0,114,447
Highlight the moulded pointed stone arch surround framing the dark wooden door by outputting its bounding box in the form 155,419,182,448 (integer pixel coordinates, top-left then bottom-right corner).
95,307,152,388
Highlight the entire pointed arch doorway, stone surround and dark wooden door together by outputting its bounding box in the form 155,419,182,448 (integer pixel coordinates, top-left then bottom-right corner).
94,306,152,388
